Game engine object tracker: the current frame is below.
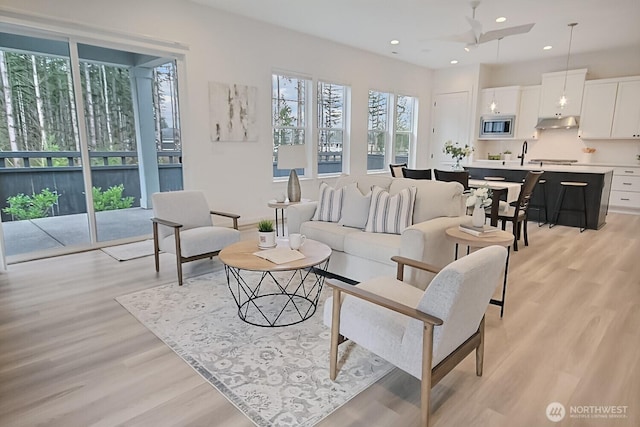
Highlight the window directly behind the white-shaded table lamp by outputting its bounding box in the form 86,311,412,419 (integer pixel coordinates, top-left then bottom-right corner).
271,74,311,178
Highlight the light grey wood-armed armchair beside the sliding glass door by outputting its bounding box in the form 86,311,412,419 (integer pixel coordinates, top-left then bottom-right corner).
151,191,240,286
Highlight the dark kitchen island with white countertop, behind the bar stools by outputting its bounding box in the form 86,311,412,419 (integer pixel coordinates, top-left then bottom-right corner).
465,161,613,230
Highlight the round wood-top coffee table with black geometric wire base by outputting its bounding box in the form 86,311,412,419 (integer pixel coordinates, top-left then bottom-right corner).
219,239,331,327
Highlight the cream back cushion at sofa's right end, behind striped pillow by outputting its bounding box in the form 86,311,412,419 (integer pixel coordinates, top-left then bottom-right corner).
389,178,464,224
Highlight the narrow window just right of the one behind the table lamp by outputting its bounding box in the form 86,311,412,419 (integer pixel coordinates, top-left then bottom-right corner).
317,82,347,174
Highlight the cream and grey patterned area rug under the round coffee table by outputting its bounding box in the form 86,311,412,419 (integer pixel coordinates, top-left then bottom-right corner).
116,271,393,427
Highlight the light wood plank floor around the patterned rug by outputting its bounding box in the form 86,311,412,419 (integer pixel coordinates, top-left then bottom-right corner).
0,214,640,427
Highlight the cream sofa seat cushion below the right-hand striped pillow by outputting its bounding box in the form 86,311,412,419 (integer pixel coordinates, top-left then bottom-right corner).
342,232,401,265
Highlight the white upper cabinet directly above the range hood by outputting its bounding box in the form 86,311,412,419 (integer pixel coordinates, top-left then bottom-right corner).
539,68,587,117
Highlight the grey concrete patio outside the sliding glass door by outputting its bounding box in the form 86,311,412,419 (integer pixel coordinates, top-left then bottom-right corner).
2,208,153,262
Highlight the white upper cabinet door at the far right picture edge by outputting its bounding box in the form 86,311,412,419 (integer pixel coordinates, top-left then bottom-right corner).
611,80,640,139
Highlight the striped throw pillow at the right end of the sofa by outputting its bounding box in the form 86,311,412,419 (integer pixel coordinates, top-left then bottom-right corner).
365,186,416,234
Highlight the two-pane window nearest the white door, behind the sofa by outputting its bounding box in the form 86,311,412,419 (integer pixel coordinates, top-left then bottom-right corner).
367,91,416,171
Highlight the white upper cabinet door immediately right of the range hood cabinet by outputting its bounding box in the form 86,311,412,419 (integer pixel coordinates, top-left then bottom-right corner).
578,79,618,139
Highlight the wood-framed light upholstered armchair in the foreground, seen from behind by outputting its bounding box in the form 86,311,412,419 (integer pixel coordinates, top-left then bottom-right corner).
324,246,507,427
